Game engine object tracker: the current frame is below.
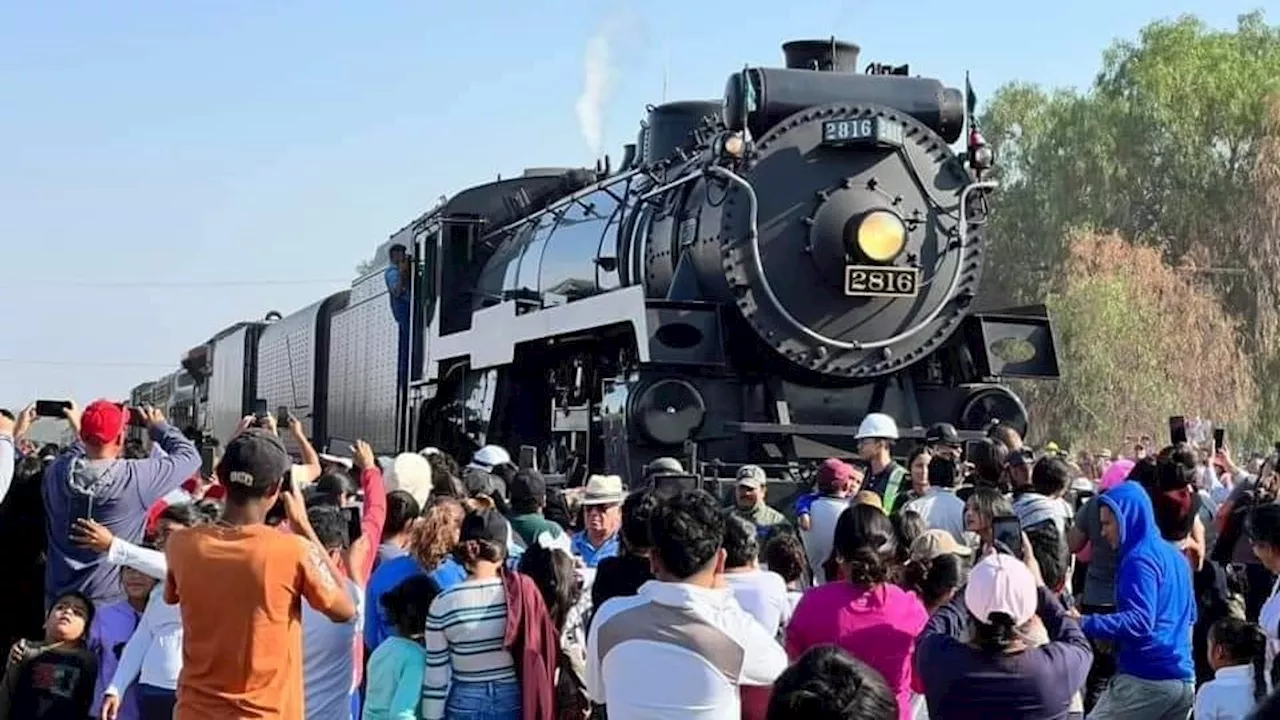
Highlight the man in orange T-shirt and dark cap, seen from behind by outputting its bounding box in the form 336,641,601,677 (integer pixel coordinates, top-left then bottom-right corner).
165,428,356,717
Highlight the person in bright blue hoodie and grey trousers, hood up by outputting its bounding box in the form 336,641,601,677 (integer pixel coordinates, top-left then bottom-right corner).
1080,482,1196,720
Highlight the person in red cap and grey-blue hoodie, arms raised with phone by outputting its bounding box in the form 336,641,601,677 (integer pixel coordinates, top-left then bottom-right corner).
41,400,200,607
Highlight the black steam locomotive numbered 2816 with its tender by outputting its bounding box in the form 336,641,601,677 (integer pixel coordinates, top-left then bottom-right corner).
135,38,1059,483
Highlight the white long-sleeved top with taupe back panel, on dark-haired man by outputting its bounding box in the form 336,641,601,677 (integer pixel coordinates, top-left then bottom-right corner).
586,580,787,720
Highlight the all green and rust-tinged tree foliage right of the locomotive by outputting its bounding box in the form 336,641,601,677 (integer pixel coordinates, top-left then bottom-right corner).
979,13,1280,445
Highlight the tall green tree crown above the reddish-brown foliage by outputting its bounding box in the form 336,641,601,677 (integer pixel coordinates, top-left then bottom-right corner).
982,13,1280,297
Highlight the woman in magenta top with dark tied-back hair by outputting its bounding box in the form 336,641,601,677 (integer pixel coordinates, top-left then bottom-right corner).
786,505,928,720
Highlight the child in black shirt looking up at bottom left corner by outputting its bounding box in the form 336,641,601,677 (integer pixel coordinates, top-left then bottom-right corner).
0,591,97,720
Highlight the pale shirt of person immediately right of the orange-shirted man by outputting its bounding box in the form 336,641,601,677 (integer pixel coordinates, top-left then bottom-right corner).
302,579,365,720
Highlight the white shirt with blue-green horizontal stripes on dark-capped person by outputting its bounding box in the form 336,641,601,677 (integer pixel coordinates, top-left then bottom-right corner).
422,578,516,720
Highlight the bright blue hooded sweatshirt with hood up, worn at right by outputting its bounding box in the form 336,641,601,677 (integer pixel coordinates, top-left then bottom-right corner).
1080,482,1196,682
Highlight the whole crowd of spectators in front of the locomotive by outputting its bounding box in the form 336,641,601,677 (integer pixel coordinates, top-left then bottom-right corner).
0,401,1280,720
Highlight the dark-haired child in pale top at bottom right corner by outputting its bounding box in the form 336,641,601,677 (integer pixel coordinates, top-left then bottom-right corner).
1194,609,1267,720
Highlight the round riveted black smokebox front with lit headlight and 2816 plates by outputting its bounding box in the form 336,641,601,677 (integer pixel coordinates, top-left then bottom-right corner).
700,102,982,380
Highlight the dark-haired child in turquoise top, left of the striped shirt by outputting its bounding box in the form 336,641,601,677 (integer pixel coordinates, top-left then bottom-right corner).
364,575,440,720
